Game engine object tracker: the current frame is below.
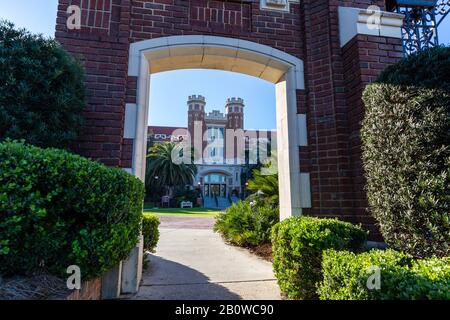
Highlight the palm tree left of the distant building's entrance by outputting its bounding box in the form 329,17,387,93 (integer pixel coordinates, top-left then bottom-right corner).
147,142,197,194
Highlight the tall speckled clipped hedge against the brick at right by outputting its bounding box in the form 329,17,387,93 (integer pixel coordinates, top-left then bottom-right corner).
362,84,450,257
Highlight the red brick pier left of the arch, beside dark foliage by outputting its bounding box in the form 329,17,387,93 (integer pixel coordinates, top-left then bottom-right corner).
55,0,132,166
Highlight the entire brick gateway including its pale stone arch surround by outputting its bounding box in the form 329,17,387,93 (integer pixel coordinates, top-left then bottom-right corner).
56,0,403,297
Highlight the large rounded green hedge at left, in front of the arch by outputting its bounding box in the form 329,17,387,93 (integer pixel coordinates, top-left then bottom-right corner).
0,141,144,280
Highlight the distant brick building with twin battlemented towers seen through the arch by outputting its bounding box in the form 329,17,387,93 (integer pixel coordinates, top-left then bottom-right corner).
148,95,276,198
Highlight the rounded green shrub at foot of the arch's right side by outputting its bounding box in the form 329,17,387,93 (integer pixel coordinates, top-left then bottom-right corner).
272,217,367,299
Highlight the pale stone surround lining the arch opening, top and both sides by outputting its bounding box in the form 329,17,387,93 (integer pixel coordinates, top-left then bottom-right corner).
124,35,311,218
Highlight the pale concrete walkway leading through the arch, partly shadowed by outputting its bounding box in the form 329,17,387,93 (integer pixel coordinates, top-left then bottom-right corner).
133,217,280,300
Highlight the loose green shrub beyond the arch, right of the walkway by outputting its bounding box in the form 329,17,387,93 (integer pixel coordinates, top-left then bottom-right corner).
214,201,279,246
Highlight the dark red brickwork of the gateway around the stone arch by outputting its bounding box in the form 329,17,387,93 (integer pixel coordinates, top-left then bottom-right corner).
56,0,402,238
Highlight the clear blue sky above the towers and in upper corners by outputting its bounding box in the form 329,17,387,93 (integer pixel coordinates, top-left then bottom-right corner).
0,0,450,129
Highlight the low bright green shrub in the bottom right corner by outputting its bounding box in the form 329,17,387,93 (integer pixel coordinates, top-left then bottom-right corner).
318,250,450,300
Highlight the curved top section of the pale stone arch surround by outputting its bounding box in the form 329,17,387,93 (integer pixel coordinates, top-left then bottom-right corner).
128,35,305,90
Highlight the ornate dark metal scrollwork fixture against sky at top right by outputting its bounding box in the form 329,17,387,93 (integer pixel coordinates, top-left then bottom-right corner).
387,0,450,54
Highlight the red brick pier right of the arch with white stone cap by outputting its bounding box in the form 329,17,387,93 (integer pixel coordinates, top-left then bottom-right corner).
300,0,401,236
